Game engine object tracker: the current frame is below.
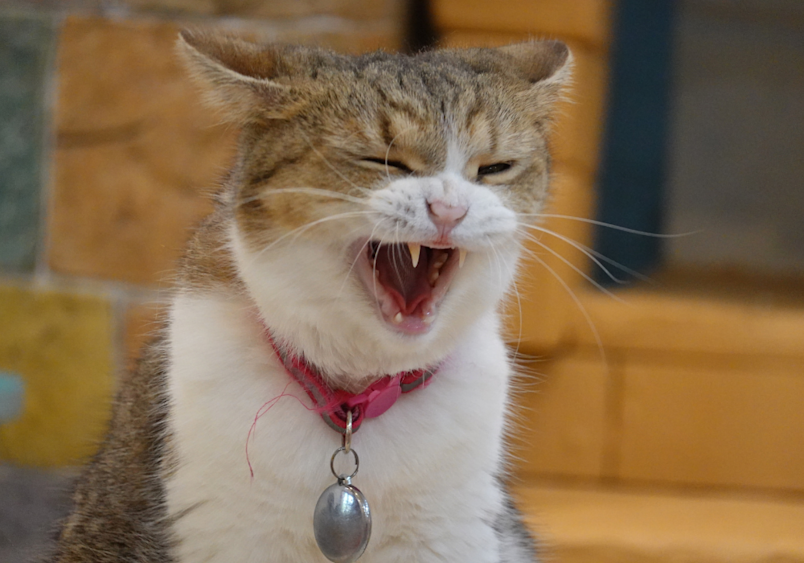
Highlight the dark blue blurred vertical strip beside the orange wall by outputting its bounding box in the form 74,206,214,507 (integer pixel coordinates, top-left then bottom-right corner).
594,0,675,284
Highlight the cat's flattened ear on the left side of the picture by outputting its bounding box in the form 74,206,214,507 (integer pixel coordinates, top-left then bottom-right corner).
176,30,299,123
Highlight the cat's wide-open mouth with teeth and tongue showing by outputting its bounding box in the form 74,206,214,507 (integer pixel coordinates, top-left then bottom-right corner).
355,240,466,334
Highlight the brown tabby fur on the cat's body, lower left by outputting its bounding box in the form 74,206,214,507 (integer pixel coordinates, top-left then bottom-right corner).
52,337,171,563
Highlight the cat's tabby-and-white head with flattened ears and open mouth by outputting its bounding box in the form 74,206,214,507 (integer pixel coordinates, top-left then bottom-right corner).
179,33,571,382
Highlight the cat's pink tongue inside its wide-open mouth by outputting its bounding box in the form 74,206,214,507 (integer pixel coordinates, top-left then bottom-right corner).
373,244,433,315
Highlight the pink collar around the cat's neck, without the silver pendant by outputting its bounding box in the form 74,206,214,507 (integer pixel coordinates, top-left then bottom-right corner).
265,327,438,434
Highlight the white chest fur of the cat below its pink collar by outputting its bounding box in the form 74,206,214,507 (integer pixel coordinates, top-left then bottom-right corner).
167,295,509,563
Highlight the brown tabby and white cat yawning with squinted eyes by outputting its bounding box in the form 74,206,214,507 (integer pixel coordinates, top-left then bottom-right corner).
51,31,572,563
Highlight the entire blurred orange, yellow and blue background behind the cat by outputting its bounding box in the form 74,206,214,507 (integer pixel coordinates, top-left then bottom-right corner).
0,0,804,563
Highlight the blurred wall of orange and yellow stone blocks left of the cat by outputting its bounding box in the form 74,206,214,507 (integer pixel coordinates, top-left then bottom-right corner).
0,0,405,466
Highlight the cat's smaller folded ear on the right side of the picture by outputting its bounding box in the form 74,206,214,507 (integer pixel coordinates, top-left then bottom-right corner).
497,41,573,90
